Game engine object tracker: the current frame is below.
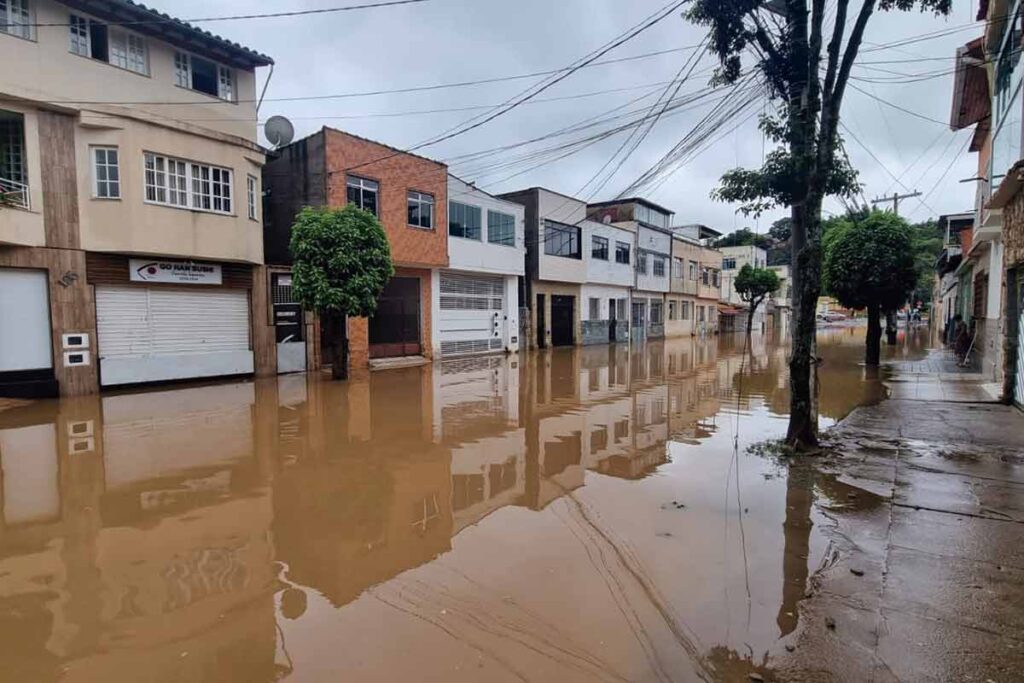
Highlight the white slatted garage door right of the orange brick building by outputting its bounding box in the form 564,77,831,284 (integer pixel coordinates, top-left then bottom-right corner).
438,272,505,356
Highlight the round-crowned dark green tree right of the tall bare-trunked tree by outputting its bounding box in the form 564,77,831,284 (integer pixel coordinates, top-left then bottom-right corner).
822,211,918,366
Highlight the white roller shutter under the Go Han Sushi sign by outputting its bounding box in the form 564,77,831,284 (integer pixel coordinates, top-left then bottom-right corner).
96,286,253,386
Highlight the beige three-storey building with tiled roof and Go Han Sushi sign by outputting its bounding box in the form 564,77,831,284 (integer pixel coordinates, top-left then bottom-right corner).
0,0,272,395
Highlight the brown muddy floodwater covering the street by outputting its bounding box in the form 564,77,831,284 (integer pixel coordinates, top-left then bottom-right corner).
0,330,922,681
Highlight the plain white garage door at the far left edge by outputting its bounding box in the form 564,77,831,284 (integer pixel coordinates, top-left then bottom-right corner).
0,268,53,373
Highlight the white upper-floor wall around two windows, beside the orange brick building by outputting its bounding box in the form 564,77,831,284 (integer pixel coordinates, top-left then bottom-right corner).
447,175,526,275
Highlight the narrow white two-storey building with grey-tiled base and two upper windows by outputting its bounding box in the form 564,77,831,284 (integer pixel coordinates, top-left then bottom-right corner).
580,220,636,344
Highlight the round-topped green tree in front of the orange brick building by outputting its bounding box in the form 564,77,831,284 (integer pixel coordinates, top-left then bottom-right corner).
290,204,394,380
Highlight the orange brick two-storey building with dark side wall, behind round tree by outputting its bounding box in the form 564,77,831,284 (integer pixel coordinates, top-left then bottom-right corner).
264,127,446,369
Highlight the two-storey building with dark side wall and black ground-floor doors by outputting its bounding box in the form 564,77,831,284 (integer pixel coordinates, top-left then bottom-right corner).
499,187,587,348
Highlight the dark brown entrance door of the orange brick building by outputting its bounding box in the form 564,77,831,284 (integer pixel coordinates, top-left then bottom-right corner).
370,278,423,358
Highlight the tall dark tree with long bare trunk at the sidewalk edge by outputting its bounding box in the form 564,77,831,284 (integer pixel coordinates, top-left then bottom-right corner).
687,0,952,450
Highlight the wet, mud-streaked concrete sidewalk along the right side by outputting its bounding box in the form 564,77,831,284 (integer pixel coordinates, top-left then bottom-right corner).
774,358,1024,681
